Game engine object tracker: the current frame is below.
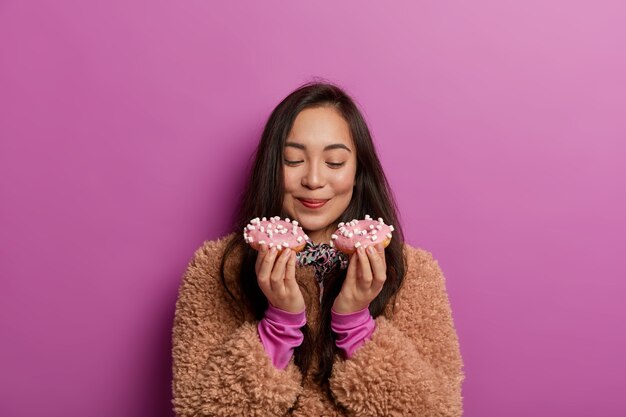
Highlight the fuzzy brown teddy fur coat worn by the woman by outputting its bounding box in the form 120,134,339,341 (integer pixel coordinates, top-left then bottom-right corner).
172,235,464,417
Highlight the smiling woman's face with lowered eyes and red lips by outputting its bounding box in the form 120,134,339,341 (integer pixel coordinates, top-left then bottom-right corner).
283,107,356,243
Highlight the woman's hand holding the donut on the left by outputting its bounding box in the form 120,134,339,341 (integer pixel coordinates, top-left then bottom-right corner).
254,245,305,313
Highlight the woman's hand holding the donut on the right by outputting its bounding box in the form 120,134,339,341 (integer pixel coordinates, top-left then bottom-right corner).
333,245,387,314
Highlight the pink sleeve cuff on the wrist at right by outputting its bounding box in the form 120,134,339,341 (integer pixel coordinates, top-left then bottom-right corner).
330,307,376,359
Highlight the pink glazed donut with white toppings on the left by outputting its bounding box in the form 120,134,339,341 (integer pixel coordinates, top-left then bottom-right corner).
243,216,309,253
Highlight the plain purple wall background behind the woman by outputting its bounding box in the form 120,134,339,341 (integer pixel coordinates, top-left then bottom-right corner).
0,0,626,417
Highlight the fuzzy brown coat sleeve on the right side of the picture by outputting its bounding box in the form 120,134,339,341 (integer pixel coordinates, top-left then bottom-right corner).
330,246,464,417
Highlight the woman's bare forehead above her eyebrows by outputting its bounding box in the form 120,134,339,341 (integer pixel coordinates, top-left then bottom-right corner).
287,107,352,148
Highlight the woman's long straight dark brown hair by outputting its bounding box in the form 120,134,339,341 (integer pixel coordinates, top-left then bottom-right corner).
220,82,405,387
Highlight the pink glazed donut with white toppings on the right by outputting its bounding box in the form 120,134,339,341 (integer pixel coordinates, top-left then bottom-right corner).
330,214,394,255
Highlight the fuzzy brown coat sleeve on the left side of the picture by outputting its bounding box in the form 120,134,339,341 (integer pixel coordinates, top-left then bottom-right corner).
172,240,302,417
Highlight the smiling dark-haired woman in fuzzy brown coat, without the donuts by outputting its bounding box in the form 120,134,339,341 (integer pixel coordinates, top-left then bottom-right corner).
173,83,463,416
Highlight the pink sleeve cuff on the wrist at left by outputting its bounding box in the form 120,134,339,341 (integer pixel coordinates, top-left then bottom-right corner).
257,304,306,369
